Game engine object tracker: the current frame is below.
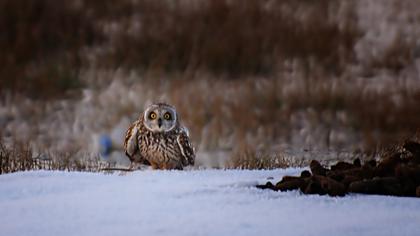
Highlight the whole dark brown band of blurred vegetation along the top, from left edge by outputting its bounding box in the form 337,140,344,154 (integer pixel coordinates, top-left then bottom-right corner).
0,0,360,98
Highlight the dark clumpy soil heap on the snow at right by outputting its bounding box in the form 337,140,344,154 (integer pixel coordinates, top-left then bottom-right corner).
257,141,420,197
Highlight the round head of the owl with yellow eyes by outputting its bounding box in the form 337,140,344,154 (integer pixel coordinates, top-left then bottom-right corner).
143,103,178,132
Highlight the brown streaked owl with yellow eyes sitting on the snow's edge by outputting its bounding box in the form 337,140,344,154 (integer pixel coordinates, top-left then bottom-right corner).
124,103,195,170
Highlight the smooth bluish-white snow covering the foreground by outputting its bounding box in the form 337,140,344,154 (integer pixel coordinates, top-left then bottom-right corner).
0,169,420,236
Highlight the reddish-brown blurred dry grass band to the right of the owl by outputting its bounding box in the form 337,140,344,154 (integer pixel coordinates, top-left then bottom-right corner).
168,74,420,155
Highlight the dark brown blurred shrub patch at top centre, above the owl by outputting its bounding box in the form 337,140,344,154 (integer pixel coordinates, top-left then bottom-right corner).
105,0,359,75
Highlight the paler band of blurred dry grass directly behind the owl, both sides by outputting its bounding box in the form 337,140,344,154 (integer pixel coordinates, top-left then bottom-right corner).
5,74,420,170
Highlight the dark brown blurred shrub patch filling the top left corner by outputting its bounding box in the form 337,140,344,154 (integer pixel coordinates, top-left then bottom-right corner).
0,0,100,98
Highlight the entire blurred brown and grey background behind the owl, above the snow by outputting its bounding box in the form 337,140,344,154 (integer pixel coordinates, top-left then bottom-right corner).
0,0,420,168
